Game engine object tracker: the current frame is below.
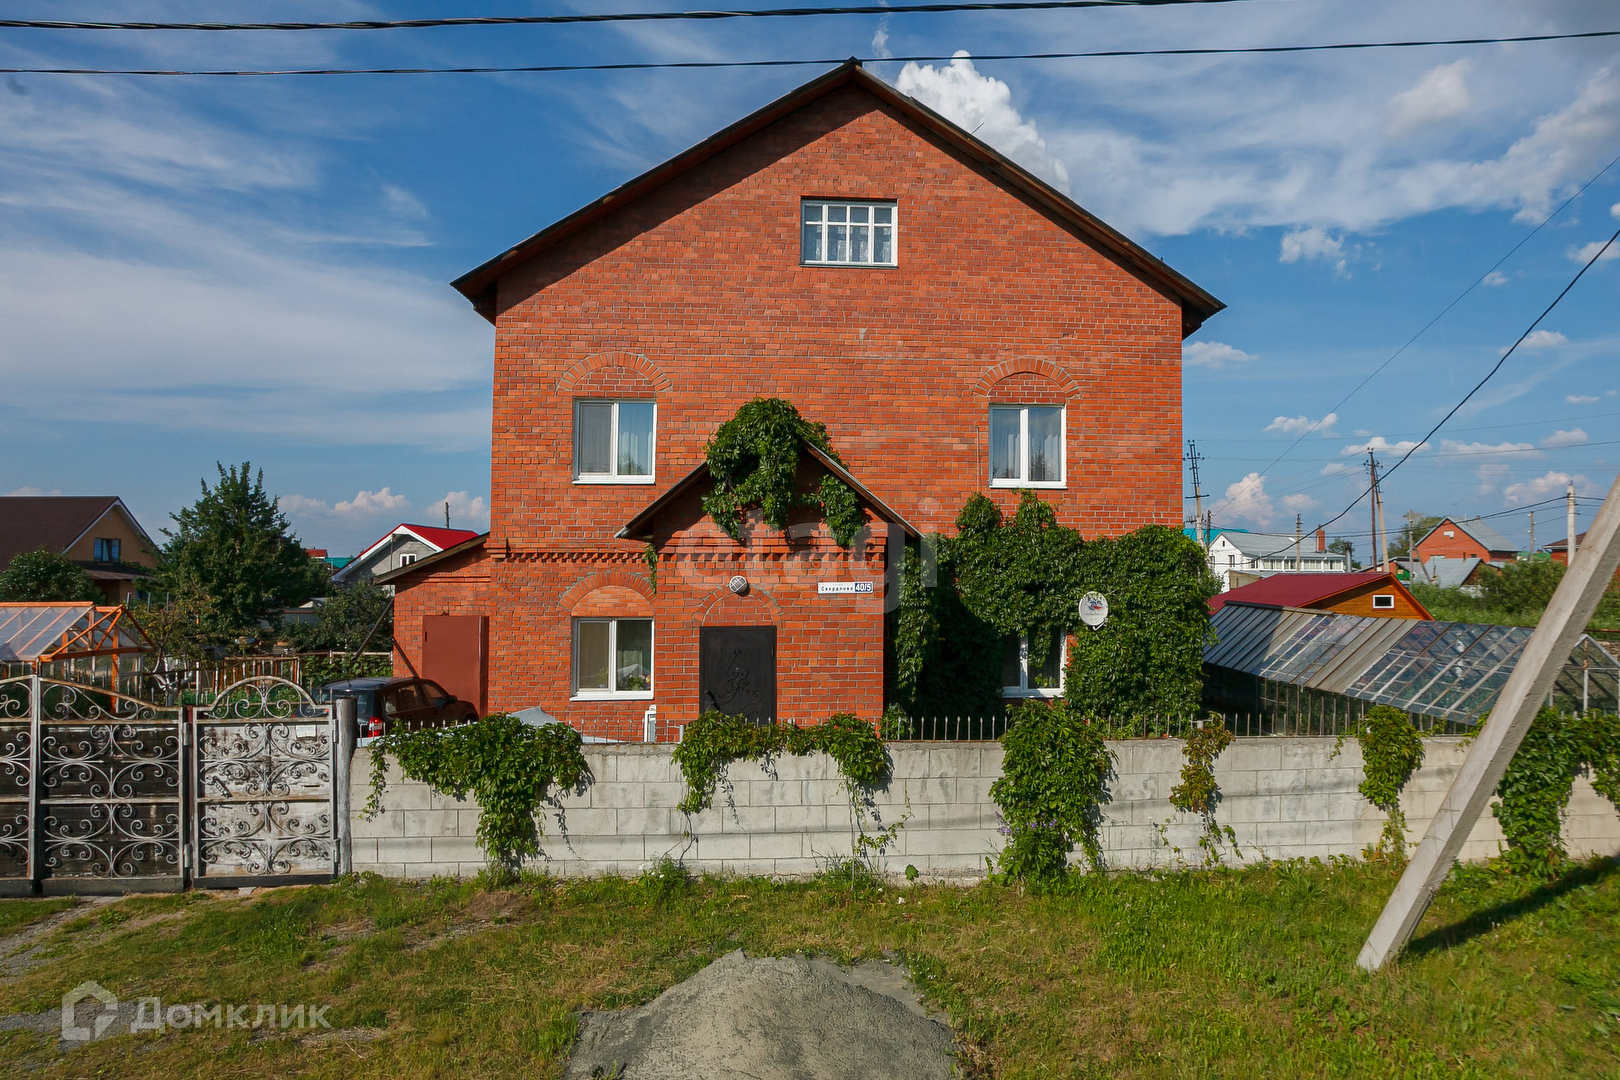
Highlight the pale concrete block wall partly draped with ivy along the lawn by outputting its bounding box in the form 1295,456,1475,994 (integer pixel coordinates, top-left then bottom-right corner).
352,738,1620,879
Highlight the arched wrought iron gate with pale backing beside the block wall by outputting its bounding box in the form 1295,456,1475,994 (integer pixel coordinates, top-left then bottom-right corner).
193,675,337,878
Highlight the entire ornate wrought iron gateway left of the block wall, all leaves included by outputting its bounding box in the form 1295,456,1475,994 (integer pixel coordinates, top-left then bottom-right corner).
0,675,337,895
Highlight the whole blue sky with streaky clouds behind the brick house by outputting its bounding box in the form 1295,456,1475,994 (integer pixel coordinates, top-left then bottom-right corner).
0,0,1620,554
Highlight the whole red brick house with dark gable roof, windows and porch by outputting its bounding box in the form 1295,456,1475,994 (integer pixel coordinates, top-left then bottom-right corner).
381,63,1221,738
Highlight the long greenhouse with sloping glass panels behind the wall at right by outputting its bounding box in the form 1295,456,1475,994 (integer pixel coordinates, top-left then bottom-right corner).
1204,604,1620,730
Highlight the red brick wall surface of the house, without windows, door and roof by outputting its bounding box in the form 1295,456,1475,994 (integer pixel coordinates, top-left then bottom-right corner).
397,80,1183,738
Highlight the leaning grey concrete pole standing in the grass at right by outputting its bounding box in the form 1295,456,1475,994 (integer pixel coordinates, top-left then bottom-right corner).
1356,476,1620,972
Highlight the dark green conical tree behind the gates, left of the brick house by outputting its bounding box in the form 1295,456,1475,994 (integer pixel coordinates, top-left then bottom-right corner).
157,461,326,638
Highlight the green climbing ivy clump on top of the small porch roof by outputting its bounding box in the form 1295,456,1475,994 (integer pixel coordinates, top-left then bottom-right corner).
703,398,867,547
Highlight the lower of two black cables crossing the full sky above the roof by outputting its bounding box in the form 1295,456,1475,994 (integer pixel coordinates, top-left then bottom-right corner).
0,31,1620,76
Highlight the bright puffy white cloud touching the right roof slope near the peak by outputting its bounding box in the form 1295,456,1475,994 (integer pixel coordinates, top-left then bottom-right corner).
894,49,1069,193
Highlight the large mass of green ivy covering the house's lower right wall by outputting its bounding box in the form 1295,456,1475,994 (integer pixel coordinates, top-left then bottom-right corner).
894,491,1220,719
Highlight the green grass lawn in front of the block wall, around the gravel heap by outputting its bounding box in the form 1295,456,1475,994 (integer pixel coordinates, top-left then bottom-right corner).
0,860,1620,1080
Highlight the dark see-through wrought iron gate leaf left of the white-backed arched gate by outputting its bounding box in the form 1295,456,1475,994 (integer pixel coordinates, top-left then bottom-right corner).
32,678,185,879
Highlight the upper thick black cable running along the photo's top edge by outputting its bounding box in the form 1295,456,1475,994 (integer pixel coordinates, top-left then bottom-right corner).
0,0,1249,31
